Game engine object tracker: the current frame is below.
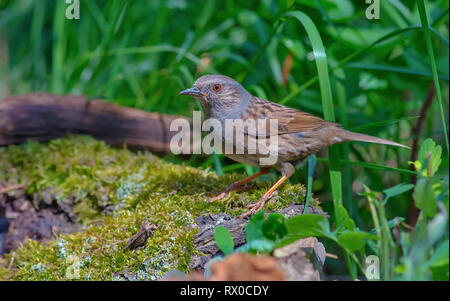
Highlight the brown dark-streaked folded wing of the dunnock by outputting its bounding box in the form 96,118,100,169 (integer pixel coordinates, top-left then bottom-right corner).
242,97,327,136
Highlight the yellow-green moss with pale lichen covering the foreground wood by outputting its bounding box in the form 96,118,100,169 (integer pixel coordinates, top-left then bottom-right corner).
0,136,312,280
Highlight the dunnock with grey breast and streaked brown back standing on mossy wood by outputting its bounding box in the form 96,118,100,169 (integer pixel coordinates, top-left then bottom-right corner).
180,75,408,217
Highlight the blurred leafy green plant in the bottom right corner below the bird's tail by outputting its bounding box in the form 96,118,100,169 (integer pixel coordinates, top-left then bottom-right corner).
362,139,449,281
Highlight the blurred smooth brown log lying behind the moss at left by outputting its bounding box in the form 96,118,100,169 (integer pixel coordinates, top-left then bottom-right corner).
0,93,185,153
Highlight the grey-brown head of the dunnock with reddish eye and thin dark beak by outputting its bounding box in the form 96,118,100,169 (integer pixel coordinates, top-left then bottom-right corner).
180,75,250,108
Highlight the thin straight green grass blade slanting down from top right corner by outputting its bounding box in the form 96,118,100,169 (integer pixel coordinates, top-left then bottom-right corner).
417,0,450,155
